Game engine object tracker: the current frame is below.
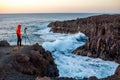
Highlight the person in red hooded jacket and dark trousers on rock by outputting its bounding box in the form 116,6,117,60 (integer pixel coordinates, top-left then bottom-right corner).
16,24,22,47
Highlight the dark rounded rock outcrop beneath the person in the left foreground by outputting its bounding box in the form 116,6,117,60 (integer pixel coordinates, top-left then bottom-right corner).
0,44,59,80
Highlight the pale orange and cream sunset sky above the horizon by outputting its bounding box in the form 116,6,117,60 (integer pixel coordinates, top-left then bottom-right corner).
0,0,120,13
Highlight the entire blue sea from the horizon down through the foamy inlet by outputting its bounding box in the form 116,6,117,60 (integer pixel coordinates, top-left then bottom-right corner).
0,13,118,79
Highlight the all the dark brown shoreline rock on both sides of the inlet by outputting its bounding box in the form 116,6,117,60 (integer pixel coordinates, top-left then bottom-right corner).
0,15,120,80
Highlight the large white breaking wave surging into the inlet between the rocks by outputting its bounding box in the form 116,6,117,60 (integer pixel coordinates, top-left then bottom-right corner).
43,33,87,52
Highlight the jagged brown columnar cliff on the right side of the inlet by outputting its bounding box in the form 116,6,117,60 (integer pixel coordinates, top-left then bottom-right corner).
48,14,120,80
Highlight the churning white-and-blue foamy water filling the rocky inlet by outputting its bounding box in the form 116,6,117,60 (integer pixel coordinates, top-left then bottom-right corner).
42,33,118,79
